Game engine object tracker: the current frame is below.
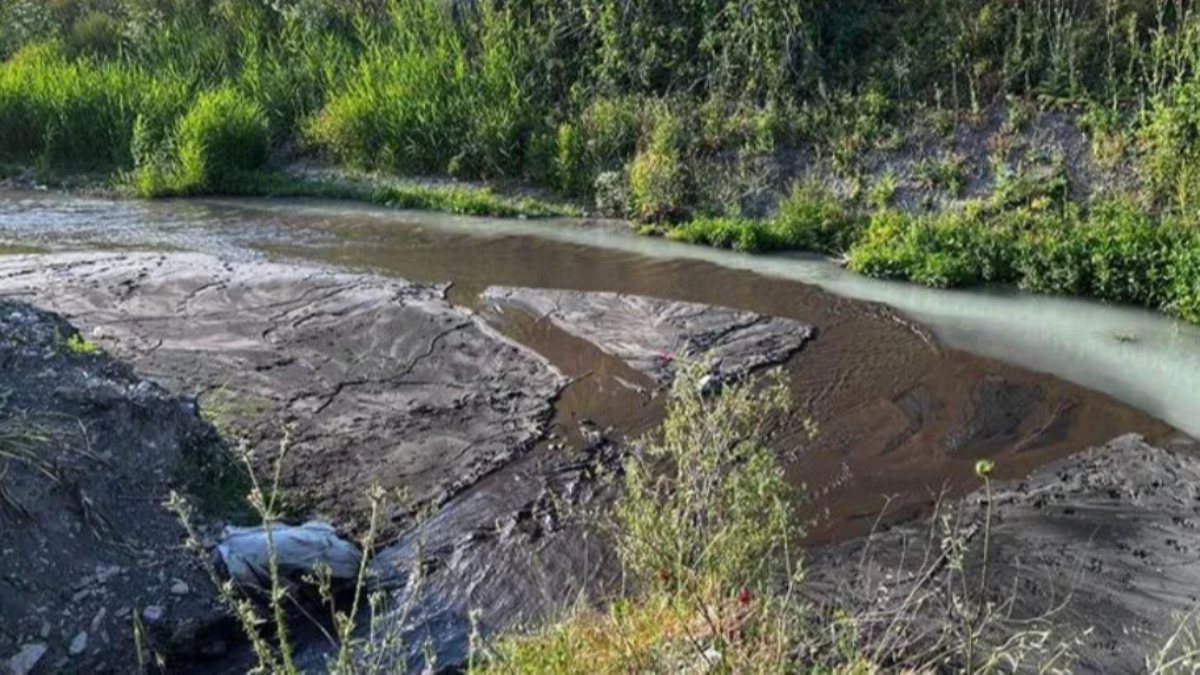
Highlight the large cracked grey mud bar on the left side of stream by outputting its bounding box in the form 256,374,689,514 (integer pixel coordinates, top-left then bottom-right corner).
0,252,568,536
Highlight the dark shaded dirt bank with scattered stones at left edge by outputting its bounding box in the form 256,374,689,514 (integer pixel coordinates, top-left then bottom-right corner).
0,300,228,674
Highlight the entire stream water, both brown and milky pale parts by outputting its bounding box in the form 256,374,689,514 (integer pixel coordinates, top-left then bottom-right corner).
0,187,1180,540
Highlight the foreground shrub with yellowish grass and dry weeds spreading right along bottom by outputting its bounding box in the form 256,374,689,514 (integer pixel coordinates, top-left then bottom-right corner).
481,366,1070,673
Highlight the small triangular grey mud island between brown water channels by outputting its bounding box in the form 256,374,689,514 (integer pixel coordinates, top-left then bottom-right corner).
484,286,815,384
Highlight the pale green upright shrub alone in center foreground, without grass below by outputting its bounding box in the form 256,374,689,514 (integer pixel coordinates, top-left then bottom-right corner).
614,365,798,593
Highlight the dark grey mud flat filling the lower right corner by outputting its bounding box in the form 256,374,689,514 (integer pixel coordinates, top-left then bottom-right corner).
809,435,1200,673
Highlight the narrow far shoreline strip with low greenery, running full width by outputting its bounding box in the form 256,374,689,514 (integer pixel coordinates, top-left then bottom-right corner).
0,163,1200,333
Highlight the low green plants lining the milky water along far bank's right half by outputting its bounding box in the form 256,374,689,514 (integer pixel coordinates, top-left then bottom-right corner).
665,181,1200,322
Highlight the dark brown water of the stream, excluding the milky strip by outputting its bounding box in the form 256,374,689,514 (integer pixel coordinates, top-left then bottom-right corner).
229,205,1174,540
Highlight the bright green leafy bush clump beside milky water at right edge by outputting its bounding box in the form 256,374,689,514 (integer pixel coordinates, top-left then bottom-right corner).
848,201,1200,321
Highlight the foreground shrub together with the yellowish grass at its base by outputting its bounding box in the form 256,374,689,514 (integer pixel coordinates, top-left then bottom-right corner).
487,364,802,674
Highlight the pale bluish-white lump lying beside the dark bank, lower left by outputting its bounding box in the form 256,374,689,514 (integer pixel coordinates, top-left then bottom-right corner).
217,522,362,587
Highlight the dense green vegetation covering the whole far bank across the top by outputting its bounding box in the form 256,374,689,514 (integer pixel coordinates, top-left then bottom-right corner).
0,0,1200,321
